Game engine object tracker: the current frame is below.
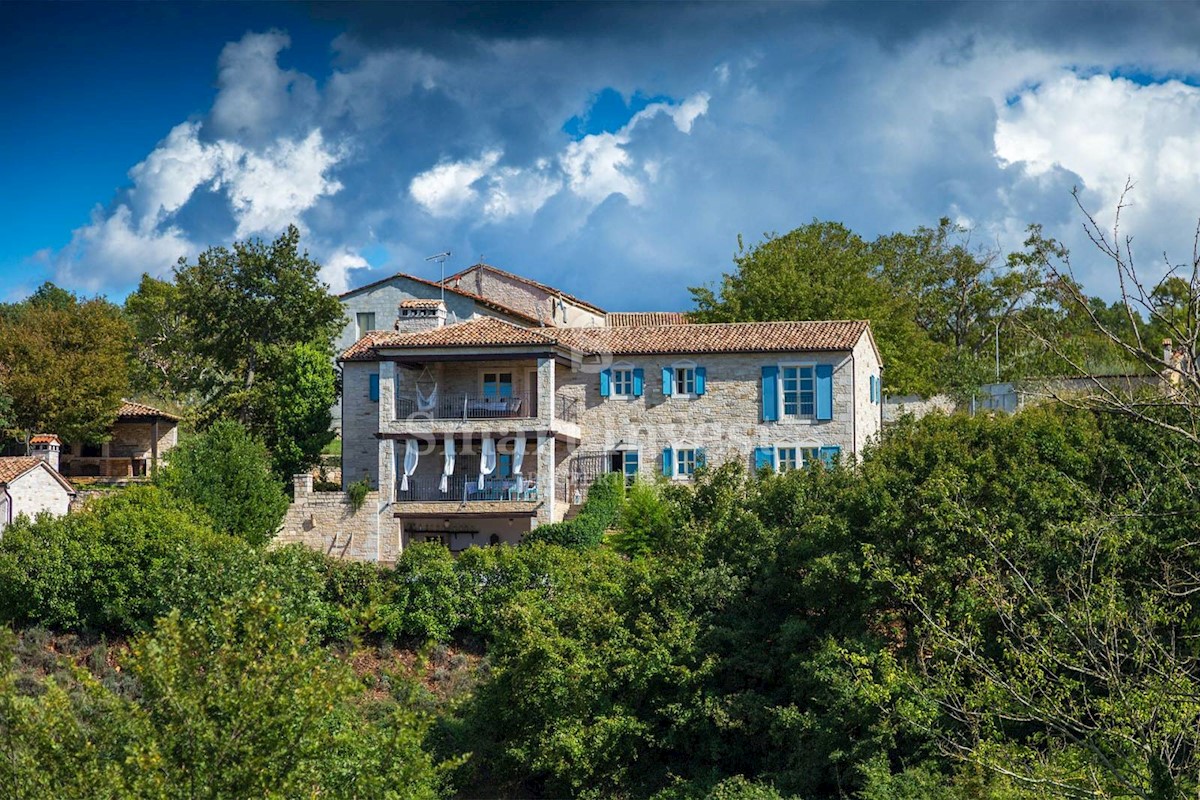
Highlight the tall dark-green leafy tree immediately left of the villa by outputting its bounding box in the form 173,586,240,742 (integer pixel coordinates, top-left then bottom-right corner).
166,225,343,476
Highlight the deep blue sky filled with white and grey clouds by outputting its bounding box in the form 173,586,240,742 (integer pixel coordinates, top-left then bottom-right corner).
7,2,1200,309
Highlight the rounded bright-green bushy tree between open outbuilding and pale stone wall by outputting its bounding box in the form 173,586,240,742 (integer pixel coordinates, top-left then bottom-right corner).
155,420,288,545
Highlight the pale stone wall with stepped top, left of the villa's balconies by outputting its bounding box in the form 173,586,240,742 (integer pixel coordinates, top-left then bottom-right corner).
271,475,400,564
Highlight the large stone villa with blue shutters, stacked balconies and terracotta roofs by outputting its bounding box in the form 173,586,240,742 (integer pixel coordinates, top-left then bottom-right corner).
314,264,882,561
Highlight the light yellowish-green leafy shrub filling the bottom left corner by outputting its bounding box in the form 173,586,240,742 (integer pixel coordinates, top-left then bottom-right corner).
0,590,440,800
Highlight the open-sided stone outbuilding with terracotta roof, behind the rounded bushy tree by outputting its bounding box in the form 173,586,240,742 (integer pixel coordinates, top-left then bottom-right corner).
60,401,179,479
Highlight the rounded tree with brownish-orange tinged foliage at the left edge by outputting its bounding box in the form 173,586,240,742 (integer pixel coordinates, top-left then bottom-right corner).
0,283,131,441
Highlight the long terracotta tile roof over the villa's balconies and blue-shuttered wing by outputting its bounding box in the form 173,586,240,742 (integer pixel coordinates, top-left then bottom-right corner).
342,317,869,361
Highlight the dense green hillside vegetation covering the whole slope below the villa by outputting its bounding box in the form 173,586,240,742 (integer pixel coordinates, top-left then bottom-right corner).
0,407,1200,800
